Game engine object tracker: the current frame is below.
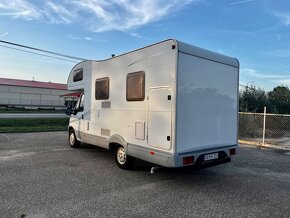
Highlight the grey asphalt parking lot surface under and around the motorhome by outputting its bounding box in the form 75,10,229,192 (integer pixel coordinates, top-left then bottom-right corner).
0,132,290,217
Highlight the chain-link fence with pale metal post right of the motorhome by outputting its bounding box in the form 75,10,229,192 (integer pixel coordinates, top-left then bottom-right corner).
239,112,290,146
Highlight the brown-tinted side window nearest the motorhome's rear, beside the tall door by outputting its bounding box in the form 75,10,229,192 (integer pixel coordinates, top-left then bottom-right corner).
126,71,145,101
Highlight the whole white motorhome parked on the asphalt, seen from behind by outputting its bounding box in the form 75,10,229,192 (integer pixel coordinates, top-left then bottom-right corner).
67,39,239,169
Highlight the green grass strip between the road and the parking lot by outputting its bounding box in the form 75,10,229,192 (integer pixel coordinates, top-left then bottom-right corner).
0,117,69,133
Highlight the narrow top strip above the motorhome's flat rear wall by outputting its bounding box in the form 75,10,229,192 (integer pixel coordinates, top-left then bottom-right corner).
175,40,239,67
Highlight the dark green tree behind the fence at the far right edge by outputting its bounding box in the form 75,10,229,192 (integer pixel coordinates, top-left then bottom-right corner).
268,86,290,114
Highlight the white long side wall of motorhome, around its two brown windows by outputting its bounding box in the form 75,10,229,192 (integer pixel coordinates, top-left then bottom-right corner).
88,40,177,152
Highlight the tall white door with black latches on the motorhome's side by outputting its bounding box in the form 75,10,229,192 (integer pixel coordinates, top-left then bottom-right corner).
147,88,172,150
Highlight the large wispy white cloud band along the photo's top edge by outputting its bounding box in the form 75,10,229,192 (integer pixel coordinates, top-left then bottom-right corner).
0,0,198,32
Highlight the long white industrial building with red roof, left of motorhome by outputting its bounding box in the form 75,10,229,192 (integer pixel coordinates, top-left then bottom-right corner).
0,78,79,109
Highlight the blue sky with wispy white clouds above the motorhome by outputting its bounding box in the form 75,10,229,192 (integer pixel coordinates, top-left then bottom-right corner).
0,0,290,91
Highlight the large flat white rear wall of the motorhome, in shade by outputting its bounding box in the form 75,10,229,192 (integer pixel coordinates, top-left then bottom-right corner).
176,53,239,152
